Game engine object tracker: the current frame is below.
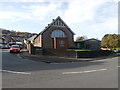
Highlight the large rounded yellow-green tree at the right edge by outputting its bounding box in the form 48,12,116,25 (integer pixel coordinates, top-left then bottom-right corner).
101,34,120,49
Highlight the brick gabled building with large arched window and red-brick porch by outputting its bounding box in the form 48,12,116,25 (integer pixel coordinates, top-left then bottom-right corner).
33,16,75,49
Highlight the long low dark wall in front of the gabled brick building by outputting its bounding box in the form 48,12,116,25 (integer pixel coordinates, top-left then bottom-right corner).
34,47,113,58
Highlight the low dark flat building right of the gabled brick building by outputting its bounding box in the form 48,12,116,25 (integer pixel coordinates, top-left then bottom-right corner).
75,39,101,50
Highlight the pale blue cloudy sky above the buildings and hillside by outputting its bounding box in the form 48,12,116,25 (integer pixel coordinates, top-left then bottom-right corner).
0,0,119,40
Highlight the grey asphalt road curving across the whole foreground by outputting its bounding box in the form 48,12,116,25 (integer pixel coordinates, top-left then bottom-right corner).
1,50,119,88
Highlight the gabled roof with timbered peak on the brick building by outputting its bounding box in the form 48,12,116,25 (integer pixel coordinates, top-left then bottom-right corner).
34,16,75,39
